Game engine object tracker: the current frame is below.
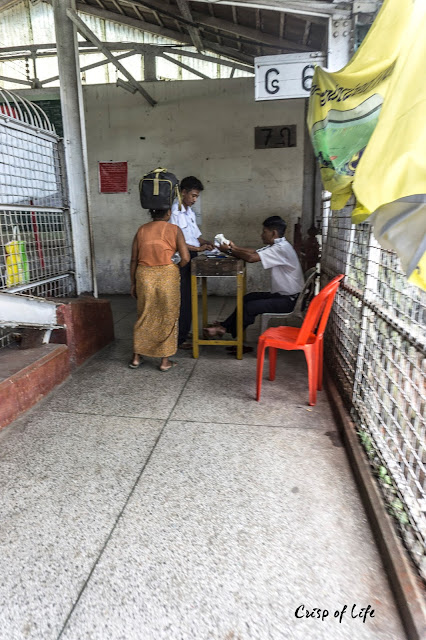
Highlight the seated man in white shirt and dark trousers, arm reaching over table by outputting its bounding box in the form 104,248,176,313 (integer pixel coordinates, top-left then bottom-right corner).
204,216,305,338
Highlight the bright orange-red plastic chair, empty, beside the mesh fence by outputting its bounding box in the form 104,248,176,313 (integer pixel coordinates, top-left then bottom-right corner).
256,274,344,407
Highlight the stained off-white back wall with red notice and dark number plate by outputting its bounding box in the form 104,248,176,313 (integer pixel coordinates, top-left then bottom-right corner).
84,78,305,293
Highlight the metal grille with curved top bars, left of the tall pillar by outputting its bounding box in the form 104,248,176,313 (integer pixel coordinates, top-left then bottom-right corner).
0,90,74,296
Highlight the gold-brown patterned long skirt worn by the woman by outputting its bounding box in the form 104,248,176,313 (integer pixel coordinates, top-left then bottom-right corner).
133,264,180,358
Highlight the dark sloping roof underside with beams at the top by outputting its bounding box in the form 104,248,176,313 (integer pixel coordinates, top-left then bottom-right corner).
77,0,333,62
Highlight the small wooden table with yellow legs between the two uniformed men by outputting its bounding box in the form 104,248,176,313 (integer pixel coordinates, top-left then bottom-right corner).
191,256,246,360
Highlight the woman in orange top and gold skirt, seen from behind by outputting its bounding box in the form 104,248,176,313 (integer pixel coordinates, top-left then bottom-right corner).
129,209,190,371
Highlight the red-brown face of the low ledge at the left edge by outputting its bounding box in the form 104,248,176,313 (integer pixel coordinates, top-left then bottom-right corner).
0,345,70,429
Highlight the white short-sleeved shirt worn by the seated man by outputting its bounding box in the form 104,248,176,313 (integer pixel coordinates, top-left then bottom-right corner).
257,238,305,296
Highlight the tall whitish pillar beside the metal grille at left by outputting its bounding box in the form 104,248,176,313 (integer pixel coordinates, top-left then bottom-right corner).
52,0,93,294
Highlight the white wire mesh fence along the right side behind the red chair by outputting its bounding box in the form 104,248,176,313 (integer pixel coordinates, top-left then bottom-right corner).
321,203,426,580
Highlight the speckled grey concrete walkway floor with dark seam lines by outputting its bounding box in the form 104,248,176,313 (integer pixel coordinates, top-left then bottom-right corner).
0,296,405,640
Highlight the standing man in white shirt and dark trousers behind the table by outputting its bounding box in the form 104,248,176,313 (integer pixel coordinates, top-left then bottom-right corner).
170,176,213,349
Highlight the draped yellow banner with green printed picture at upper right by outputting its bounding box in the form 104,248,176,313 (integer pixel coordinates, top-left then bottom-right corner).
308,0,426,289
